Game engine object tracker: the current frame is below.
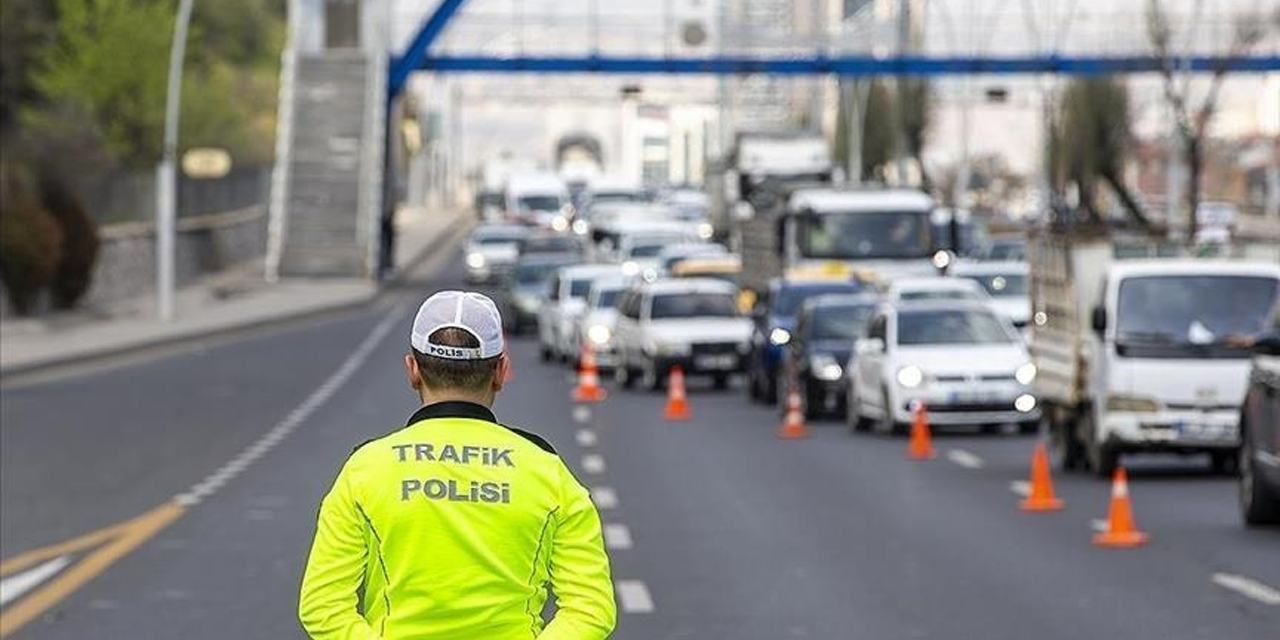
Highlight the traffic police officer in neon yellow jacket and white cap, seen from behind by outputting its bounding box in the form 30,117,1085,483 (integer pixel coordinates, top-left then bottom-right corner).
298,291,617,640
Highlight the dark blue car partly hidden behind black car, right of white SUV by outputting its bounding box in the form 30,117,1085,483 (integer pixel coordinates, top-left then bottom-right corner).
746,278,868,404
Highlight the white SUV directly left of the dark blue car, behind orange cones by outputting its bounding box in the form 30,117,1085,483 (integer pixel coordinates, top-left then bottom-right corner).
614,278,751,390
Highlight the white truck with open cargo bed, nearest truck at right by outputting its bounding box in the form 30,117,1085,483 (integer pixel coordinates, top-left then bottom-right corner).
1028,230,1280,477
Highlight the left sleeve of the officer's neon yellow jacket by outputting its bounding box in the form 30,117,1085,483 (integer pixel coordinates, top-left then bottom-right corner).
298,461,378,640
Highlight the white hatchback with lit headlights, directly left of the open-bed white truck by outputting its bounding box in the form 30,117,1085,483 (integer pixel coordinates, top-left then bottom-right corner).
847,301,1039,433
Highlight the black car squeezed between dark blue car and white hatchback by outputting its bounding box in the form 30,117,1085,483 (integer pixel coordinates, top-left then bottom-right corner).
777,294,879,419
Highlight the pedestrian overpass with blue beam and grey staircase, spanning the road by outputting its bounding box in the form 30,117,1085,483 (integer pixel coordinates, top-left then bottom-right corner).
268,0,1280,278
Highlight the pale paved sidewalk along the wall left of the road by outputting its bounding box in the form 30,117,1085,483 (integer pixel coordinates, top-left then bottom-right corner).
0,210,470,378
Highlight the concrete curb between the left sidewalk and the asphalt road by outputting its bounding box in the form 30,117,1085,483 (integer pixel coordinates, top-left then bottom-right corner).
0,220,467,383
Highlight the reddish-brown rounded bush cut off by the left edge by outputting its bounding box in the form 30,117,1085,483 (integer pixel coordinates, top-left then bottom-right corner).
0,166,63,315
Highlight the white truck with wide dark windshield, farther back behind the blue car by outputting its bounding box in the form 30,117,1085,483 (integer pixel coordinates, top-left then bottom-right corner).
735,184,943,292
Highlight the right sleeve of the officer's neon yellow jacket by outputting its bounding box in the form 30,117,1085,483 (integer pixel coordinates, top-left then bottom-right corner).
538,465,617,640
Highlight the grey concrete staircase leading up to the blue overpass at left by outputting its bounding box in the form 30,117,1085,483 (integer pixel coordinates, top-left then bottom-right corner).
279,51,384,276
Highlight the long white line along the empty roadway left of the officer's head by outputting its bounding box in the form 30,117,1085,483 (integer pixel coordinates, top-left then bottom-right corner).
174,305,408,507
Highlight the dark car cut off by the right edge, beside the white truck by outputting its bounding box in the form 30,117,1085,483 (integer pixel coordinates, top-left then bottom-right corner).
1239,310,1280,525
